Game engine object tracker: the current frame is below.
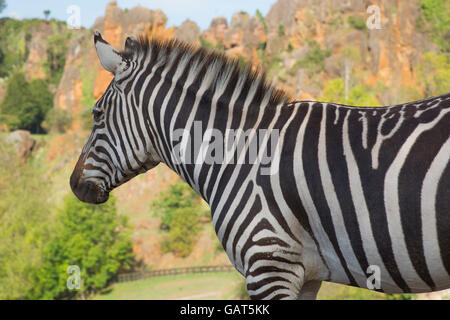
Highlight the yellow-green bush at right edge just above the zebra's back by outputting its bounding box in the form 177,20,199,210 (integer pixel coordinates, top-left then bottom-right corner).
417,52,450,97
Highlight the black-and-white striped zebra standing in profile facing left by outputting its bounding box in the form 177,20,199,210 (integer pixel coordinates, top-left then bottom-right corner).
70,31,450,299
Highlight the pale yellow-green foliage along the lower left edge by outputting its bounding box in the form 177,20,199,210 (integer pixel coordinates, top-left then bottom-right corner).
0,136,52,300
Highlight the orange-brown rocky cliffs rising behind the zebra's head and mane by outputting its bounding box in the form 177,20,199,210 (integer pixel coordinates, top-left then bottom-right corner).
53,0,436,118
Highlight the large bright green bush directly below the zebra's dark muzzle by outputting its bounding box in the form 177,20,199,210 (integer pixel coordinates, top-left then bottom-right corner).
33,195,134,299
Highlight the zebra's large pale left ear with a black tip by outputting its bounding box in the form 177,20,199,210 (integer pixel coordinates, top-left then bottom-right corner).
94,31,128,75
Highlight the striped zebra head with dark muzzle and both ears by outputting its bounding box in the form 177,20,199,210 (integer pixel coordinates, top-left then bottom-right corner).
70,31,160,204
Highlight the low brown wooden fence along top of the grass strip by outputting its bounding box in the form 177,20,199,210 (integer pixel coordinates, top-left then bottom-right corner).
117,266,234,282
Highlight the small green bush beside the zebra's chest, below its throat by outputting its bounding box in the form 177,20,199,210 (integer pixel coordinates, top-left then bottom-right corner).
151,182,209,257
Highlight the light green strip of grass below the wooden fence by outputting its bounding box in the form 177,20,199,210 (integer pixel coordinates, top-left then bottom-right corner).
94,272,243,300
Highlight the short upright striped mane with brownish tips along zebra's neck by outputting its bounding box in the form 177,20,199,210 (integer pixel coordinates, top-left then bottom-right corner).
120,35,293,105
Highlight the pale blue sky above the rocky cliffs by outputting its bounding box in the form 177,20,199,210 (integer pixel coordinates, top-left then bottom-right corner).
0,0,276,30
